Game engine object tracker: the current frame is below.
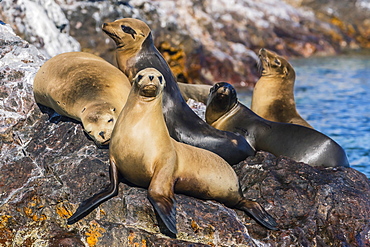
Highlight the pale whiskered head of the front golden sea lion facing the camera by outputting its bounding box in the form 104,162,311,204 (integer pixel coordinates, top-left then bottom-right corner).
132,68,166,100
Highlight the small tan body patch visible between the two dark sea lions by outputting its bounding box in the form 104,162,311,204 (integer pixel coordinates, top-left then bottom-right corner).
177,82,212,104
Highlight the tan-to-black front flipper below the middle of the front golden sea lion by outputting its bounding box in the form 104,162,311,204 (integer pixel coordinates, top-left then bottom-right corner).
148,165,177,235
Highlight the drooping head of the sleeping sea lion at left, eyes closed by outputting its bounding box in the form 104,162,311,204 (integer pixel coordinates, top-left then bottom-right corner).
81,104,117,146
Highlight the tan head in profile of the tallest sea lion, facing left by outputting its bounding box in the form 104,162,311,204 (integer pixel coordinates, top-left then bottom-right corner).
102,18,150,49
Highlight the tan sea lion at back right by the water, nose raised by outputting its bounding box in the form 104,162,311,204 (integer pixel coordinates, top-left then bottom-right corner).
251,48,312,128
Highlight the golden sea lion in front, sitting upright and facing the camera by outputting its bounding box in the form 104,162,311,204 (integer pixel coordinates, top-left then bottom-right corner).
68,68,277,234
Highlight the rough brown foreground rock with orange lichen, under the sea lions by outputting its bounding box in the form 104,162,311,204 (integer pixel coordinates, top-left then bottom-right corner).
0,25,370,247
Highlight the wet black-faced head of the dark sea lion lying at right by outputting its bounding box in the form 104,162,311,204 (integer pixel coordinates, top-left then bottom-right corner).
206,82,238,124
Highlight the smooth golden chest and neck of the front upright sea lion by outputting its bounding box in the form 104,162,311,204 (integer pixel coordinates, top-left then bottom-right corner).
110,98,174,187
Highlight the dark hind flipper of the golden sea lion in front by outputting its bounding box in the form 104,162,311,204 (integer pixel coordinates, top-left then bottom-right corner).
235,198,279,230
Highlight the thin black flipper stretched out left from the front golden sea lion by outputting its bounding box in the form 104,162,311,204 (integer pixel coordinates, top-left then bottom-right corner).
67,160,119,225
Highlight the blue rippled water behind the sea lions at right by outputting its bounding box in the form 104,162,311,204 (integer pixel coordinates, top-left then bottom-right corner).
237,51,370,178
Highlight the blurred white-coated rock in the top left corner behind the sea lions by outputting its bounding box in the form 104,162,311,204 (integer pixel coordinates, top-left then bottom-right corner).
0,0,81,57
